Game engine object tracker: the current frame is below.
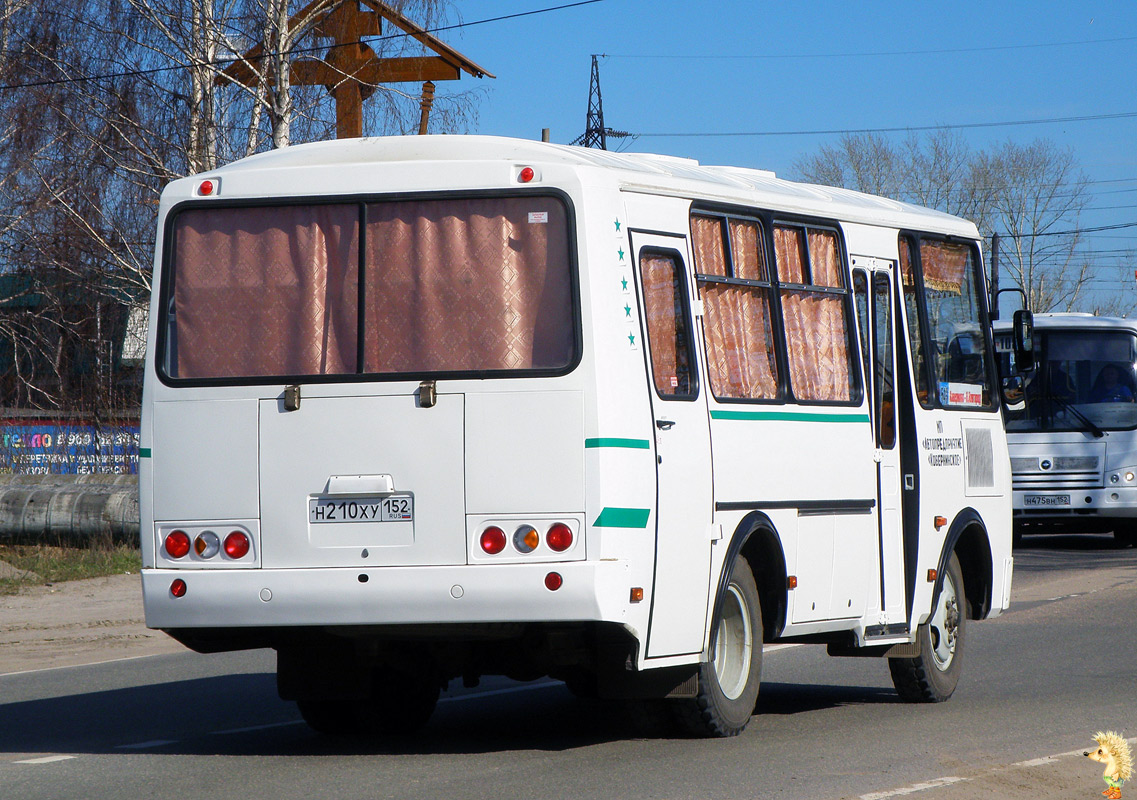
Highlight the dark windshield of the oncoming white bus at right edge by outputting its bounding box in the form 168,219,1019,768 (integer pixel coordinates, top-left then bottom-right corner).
999,330,1137,433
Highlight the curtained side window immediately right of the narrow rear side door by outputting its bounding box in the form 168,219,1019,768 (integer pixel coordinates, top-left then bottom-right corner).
691,216,778,399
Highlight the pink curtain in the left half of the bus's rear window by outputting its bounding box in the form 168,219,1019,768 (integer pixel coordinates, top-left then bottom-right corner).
169,206,359,378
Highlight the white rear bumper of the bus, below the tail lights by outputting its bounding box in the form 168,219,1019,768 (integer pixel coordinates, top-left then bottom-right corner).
142,561,632,628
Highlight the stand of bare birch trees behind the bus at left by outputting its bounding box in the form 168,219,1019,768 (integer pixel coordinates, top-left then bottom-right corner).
0,0,478,418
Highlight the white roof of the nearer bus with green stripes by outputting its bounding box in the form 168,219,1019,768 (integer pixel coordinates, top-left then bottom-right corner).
181,135,979,239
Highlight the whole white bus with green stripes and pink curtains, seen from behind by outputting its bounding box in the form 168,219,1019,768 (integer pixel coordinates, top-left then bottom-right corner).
140,136,1012,735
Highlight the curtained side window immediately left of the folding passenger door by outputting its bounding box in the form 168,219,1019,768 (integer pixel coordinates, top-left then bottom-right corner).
774,227,850,402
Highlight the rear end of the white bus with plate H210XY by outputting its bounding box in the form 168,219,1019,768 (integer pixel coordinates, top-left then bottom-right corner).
140,165,628,732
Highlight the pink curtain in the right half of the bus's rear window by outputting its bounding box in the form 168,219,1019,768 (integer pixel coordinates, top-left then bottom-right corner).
364,198,573,373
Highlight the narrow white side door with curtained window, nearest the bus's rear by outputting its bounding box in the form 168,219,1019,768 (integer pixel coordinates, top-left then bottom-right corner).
631,233,713,658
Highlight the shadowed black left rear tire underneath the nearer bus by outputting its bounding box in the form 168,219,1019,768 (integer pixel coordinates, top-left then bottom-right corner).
297,668,441,736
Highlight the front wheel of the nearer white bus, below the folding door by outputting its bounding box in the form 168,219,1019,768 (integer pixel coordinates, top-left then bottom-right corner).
888,552,968,702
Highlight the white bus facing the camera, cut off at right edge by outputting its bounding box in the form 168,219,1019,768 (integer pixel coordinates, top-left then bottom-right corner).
996,314,1137,545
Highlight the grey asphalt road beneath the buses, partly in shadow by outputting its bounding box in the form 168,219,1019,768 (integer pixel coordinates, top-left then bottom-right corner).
0,536,1137,800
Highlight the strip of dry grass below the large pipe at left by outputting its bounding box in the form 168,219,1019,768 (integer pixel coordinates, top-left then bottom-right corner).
0,544,142,594
